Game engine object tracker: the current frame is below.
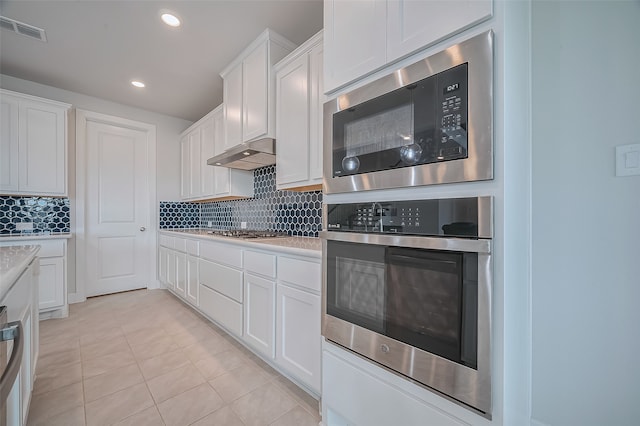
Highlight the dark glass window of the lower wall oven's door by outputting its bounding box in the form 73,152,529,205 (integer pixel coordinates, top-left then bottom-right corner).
326,241,478,369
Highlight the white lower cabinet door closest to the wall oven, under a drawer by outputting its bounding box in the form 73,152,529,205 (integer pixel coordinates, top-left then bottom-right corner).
276,283,321,393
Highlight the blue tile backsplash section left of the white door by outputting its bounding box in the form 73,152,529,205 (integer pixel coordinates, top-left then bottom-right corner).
0,196,71,235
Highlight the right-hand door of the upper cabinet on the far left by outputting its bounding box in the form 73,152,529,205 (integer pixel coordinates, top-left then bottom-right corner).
18,101,67,195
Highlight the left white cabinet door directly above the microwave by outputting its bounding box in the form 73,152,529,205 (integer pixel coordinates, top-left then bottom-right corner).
324,0,387,92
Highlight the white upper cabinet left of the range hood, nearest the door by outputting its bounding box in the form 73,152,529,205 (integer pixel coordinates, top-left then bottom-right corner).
180,105,253,201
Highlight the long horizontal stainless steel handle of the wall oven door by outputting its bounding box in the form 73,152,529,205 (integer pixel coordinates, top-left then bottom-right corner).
319,231,491,254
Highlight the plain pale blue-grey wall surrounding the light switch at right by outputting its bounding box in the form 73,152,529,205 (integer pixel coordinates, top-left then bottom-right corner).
532,1,640,426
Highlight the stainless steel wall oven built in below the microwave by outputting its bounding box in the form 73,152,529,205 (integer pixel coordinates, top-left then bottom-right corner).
321,197,493,417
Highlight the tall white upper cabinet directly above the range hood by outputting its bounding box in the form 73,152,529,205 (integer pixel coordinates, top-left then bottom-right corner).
220,29,295,150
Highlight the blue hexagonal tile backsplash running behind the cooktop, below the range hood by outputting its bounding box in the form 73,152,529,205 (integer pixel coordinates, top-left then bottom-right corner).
160,166,322,237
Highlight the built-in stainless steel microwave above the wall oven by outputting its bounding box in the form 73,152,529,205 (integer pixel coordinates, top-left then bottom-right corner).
324,31,493,194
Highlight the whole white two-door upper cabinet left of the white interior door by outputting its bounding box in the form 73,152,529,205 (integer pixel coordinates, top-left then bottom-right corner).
0,90,70,196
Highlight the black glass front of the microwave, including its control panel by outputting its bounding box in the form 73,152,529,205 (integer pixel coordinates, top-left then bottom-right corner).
332,63,468,177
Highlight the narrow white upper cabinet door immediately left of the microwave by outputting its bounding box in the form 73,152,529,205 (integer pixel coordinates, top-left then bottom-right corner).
309,43,324,184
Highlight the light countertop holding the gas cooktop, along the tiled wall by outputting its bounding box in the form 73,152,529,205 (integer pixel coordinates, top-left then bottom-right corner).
159,229,322,258
